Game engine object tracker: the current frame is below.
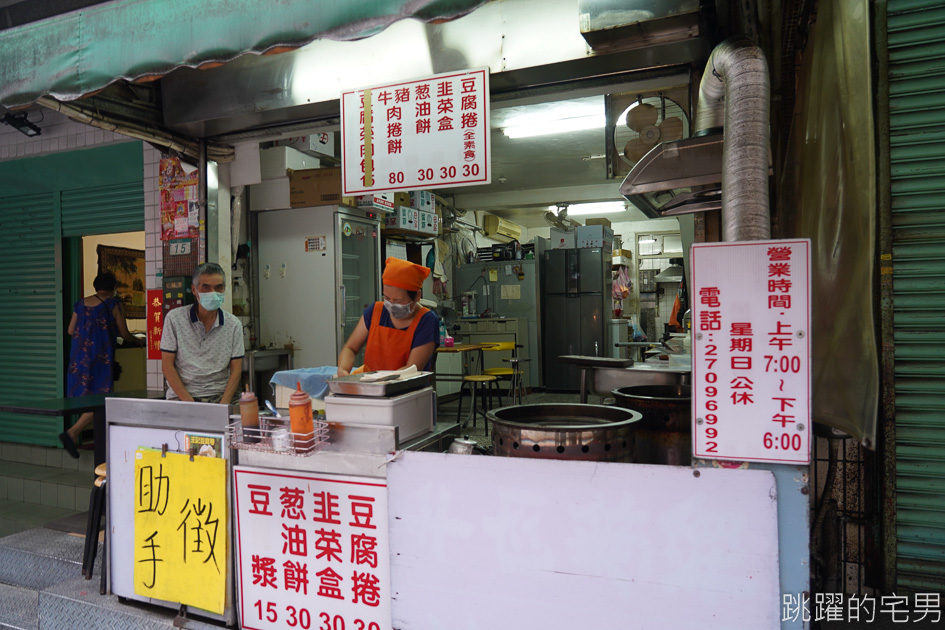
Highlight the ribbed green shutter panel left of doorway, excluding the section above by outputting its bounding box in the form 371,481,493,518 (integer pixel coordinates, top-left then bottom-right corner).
0,193,65,446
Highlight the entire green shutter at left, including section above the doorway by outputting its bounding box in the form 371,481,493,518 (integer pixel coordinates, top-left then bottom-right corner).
0,142,144,446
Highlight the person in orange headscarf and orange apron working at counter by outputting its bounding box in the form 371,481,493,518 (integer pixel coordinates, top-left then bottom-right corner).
338,258,440,376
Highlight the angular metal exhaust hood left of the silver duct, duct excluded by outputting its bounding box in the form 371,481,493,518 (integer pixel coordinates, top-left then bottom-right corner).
620,133,722,219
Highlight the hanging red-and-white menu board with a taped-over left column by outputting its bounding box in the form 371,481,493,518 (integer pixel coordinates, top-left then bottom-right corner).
341,68,492,197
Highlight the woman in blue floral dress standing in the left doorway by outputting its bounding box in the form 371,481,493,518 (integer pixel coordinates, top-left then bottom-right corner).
59,271,142,457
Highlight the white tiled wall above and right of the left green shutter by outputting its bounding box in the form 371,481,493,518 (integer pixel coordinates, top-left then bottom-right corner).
0,108,164,389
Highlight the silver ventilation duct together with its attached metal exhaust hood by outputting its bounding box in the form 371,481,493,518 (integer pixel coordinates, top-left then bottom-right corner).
620,39,771,241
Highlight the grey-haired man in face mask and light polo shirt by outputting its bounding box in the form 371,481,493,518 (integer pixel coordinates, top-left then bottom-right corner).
161,263,244,405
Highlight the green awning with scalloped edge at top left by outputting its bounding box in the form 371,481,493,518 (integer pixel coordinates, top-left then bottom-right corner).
0,0,489,107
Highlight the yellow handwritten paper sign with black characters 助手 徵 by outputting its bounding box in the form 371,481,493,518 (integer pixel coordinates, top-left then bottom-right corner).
134,450,227,614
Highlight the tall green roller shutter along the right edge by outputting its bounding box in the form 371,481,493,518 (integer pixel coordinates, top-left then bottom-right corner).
887,0,945,592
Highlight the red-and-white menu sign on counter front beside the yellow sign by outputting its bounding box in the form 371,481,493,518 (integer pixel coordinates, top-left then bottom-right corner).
233,466,391,630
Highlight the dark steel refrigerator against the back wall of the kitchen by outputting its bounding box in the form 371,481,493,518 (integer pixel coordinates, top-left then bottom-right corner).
541,248,613,391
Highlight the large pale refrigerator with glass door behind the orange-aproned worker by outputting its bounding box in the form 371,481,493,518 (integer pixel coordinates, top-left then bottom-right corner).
257,206,381,368
